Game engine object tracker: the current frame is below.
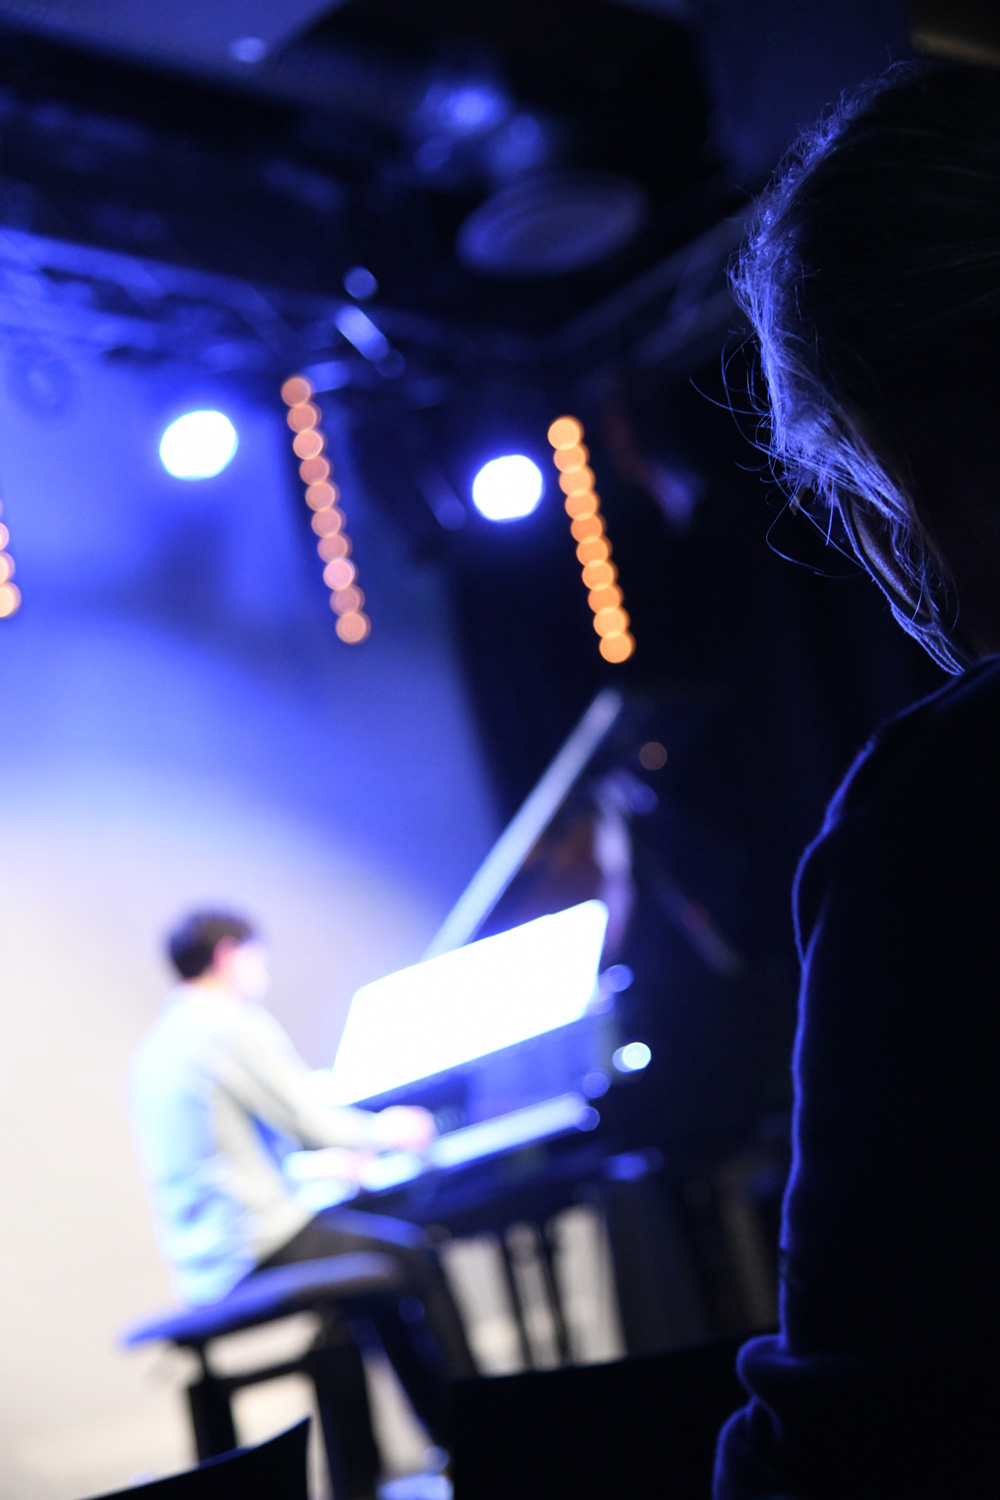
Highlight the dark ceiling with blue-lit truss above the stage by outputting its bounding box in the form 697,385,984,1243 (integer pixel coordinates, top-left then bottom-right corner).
0,0,953,390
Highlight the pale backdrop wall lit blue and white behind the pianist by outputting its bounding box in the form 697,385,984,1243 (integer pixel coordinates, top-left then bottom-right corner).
0,360,496,1500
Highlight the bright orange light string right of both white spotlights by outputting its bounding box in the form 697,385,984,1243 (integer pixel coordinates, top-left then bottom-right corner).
549,417,636,662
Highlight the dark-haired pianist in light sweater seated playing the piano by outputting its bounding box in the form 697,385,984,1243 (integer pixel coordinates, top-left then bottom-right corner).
129,911,475,1448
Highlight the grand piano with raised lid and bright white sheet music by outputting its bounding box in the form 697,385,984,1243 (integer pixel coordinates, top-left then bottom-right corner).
289,690,773,1368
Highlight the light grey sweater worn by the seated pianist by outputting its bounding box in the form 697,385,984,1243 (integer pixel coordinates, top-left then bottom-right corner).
129,984,378,1304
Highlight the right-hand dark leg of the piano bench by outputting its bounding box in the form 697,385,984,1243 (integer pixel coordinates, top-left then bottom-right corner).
303,1319,381,1500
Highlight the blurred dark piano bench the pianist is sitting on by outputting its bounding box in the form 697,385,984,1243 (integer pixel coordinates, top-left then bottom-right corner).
121,1251,400,1500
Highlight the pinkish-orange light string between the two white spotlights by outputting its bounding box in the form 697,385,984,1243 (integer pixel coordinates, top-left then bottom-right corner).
282,375,372,647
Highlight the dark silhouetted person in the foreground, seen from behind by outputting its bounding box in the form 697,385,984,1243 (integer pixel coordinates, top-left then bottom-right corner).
715,65,1000,1500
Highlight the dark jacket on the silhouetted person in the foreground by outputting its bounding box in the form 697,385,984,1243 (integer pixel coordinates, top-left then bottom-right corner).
715,657,1000,1500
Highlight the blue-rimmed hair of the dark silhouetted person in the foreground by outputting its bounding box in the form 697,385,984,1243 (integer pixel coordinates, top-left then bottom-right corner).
733,63,1000,672
